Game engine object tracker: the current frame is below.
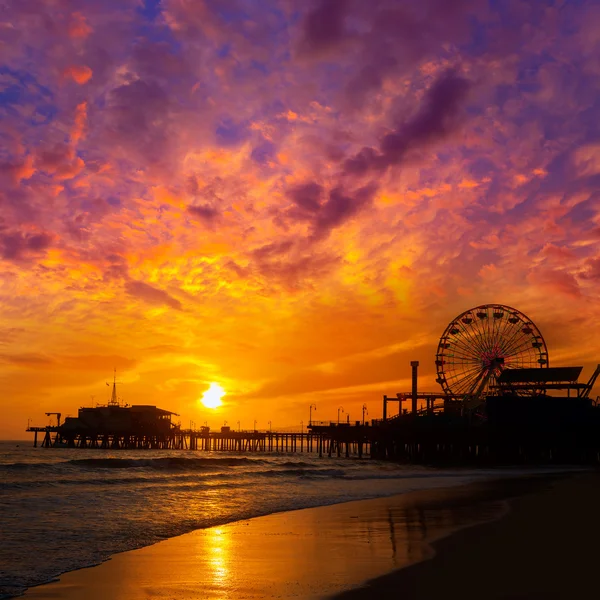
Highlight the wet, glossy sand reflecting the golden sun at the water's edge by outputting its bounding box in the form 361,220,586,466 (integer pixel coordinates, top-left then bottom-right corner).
22,472,570,600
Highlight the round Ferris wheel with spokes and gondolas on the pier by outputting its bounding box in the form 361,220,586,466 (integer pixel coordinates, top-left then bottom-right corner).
435,304,548,397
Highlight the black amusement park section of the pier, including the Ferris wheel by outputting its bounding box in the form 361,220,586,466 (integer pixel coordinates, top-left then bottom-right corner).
360,304,600,463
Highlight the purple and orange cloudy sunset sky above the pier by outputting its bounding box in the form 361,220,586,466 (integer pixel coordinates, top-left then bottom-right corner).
0,0,600,439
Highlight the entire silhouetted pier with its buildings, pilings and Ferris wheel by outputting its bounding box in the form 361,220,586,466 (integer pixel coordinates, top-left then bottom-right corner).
28,304,600,464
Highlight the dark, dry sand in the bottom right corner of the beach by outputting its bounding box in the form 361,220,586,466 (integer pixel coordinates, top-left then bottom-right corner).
336,473,600,600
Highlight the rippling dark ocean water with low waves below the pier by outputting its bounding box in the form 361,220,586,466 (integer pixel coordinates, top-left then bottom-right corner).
0,441,568,599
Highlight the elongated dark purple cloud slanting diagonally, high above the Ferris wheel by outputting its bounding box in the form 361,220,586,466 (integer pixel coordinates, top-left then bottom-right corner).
344,70,471,175
